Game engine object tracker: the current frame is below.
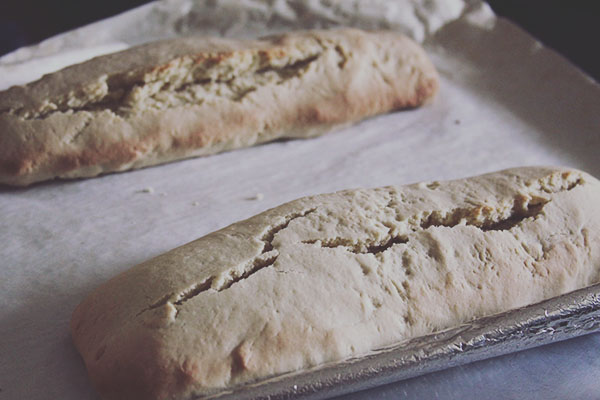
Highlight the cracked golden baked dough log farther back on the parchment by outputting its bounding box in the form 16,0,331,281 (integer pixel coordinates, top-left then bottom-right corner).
0,29,438,185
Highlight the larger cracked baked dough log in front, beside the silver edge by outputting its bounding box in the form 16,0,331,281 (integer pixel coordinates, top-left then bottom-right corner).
71,168,600,399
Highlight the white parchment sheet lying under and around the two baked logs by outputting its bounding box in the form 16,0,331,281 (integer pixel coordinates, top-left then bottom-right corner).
0,0,600,400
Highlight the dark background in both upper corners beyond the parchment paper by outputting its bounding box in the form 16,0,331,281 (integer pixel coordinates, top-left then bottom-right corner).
0,0,600,81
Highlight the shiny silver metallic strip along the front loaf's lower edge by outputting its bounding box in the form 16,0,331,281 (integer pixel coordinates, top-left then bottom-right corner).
210,284,600,400
